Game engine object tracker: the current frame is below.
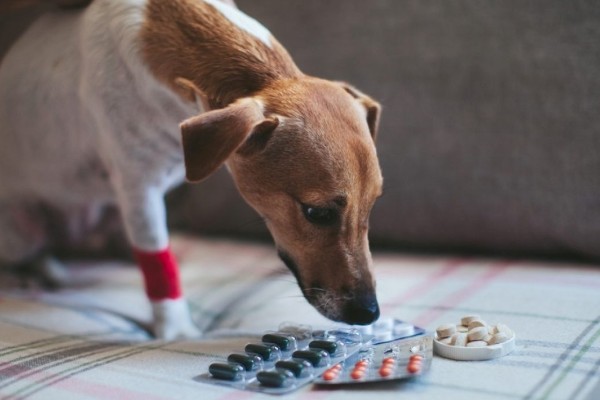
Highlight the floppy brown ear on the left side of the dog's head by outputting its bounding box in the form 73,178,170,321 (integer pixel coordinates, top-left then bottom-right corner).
180,98,277,182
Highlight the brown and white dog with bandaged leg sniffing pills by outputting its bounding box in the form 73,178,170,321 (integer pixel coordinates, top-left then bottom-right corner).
0,0,383,339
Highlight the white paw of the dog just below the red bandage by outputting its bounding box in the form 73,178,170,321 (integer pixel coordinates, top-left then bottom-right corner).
152,298,201,340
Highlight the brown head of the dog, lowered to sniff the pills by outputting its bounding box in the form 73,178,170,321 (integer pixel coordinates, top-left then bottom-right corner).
181,78,382,324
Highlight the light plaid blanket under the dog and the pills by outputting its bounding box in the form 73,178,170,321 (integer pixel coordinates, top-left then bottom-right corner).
0,236,600,400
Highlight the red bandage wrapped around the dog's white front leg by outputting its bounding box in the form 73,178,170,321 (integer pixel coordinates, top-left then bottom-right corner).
133,247,181,300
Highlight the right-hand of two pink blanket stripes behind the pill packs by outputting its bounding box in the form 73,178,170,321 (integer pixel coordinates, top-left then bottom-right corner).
412,262,510,326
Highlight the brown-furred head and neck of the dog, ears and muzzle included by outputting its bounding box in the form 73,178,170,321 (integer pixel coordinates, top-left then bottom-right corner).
142,0,382,323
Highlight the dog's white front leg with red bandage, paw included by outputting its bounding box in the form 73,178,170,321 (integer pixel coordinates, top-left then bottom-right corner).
115,182,200,340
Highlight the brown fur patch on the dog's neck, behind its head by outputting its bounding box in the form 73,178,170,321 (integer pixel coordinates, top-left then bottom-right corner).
142,1,301,108
